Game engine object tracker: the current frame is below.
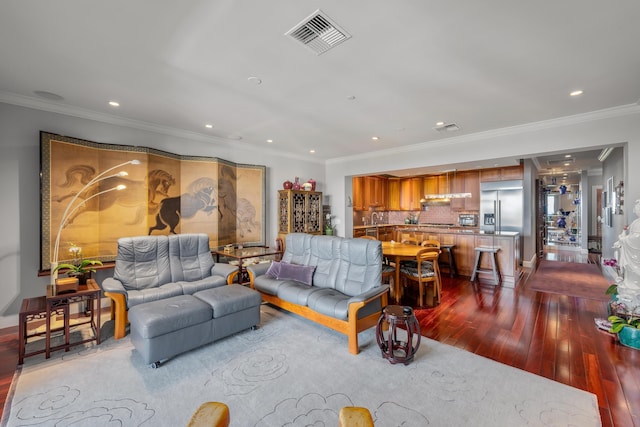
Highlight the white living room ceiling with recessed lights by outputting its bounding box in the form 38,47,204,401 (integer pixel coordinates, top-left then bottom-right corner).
0,0,640,174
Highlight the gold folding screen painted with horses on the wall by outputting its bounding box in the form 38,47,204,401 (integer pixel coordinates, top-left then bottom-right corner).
40,132,266,270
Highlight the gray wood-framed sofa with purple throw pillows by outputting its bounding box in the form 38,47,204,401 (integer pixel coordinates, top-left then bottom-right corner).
247,233,389,354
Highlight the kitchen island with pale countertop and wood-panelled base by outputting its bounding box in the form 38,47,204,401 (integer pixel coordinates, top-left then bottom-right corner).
353,224,522,288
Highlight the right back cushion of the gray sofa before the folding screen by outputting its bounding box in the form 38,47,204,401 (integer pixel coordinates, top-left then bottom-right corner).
169,233,214,282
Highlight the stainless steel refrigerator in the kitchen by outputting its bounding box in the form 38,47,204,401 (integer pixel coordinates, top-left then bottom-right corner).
480,180,524,239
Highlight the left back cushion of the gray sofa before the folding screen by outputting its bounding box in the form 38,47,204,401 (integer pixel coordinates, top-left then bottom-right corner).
113,236,172,291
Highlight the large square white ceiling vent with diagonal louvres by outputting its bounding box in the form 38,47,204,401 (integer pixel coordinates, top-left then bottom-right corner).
285,9,351,55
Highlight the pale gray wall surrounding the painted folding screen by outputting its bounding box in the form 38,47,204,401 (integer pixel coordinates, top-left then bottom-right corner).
0,103,326,328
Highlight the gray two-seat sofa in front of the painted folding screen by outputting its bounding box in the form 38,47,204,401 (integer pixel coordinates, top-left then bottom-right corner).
101,234,237,339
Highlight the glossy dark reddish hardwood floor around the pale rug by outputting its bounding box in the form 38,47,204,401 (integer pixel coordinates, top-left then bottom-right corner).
0,252,640,427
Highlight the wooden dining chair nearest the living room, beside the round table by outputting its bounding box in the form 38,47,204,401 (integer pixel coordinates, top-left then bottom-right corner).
400,247,442,306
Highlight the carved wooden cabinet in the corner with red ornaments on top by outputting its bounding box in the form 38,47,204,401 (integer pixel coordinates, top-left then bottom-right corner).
278,190,322,238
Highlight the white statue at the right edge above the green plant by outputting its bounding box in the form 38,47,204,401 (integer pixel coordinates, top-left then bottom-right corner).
613,200,640,308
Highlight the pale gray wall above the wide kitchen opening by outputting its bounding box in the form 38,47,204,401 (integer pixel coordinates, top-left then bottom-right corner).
326,104,640,268
